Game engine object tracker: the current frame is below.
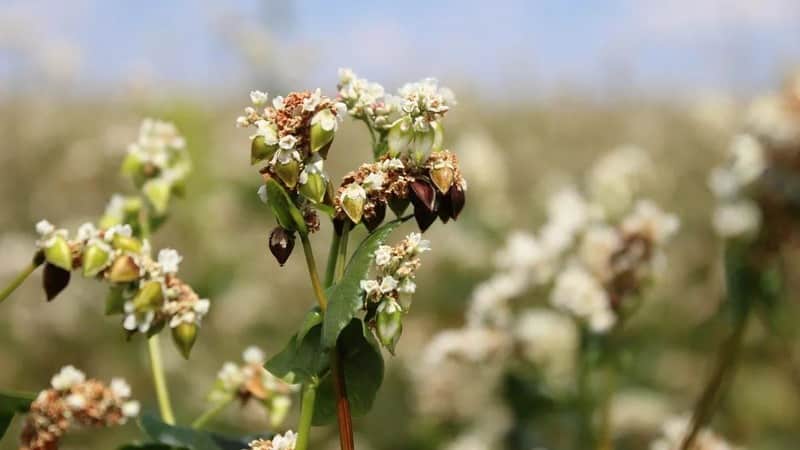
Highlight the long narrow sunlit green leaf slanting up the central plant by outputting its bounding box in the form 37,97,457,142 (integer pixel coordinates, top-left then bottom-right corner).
322,220,401,348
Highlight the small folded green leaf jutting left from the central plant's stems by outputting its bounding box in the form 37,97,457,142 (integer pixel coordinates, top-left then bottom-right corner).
264,324,328,382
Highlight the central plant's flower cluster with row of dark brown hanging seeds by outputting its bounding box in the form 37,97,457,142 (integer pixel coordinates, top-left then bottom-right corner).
335,150,467,231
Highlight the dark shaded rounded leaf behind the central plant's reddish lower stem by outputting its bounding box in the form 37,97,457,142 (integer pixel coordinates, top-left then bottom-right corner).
313,319,384,425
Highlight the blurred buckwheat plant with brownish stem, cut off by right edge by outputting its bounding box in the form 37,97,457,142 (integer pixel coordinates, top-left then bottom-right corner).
682,70,800,449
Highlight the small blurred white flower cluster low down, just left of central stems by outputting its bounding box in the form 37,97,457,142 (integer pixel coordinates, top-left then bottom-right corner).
209,347,297,427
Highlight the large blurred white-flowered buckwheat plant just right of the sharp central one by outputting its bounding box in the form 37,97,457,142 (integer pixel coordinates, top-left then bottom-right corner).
414,147,679,449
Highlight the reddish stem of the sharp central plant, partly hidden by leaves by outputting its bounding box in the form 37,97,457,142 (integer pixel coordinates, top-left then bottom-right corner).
300,228,355,450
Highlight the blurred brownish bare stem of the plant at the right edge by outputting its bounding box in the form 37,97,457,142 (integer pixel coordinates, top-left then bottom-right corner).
681,312,750,450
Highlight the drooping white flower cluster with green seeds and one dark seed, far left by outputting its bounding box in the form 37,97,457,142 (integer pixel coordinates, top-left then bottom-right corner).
36,220,210,357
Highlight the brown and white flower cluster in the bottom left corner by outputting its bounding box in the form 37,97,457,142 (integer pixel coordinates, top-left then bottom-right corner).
20,366,139,450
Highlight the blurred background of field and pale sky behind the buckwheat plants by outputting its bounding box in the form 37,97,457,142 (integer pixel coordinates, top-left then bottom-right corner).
0,0,800,450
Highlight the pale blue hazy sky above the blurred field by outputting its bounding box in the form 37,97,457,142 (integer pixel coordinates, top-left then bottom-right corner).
0,0,800,96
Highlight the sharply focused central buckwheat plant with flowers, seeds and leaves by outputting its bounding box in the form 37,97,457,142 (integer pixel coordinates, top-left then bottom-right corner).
237,69,467,450
